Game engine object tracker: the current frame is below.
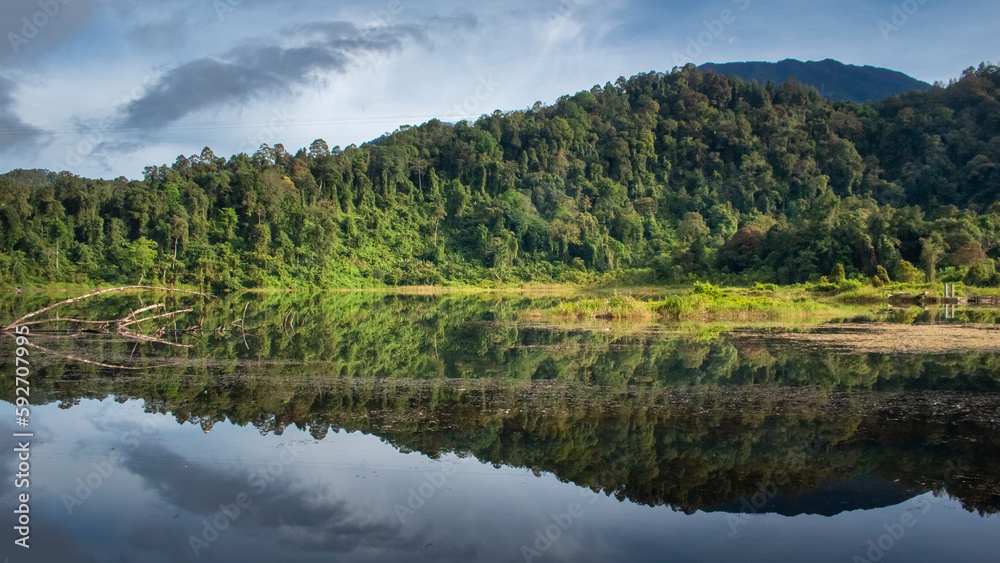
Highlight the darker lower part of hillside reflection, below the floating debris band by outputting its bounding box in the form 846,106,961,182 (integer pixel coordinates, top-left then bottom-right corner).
7,368,1000,513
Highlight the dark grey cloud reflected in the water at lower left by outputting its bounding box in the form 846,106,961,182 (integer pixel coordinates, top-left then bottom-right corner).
117,444,475,560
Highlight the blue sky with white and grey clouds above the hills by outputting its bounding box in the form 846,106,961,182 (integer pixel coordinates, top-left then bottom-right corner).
0,0,1000,178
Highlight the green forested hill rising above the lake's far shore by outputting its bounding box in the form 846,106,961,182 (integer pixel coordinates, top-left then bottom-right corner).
0,65,1000,289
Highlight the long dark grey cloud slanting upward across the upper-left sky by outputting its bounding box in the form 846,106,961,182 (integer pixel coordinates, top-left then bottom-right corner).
121,22,426,129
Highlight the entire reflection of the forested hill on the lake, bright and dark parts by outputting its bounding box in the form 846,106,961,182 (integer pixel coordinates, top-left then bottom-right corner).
0,293,1000,513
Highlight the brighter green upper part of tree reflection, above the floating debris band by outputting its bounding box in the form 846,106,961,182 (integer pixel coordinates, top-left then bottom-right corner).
7,292,1000,390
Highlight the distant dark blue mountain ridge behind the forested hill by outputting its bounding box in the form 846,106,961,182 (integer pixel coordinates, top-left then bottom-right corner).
698,59,931,103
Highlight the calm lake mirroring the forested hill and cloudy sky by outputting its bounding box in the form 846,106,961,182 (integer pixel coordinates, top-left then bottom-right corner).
0,292,1000,563
